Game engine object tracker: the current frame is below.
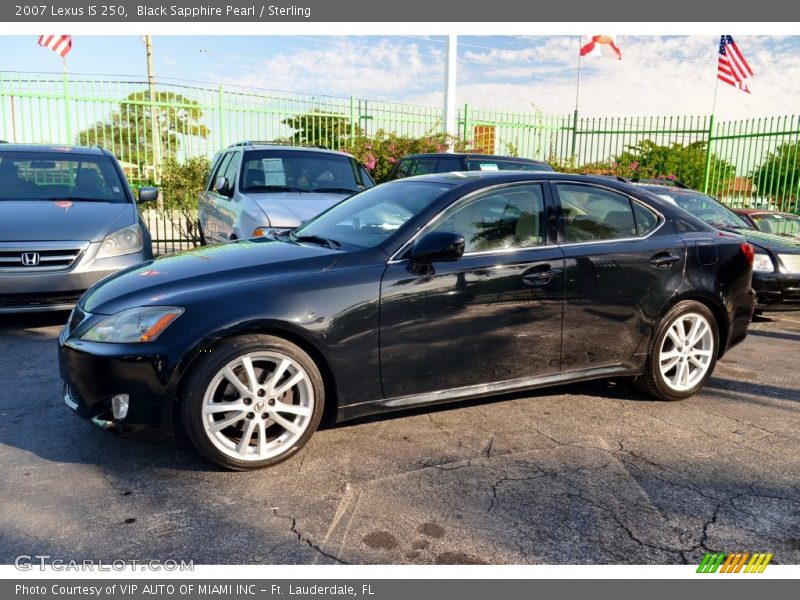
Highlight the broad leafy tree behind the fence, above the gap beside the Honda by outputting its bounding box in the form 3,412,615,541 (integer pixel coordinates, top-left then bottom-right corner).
77,90,209,174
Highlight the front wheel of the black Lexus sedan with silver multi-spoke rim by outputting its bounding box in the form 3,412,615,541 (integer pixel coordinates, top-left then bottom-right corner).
180,335,325,471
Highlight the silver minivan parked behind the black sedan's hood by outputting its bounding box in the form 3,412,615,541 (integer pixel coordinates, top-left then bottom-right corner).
199,142,375,245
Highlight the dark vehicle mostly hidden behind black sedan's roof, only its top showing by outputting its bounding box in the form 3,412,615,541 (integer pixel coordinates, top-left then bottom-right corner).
386,152,553,181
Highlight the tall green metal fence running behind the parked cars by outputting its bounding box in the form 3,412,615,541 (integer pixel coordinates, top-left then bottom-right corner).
0,73,800,251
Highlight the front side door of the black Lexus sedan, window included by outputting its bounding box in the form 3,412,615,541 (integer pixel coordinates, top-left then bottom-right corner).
380,182,564,398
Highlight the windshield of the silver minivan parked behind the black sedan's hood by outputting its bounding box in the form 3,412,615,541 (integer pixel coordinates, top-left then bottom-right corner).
239,150,374,194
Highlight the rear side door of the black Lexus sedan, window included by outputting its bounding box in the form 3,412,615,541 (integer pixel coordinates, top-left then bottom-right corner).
552,182,686,371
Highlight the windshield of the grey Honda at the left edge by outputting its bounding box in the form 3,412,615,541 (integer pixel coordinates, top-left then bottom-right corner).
0,151,128,202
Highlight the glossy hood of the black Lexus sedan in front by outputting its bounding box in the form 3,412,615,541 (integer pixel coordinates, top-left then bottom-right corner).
80,238,344,314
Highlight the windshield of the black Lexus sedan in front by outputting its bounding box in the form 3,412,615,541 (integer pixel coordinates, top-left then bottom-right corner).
291,180,452,249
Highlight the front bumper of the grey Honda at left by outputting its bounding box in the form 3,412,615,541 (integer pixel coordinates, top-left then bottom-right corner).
0,243,152,314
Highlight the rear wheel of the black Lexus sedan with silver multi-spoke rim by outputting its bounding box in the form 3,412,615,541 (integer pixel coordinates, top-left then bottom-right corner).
636,300,719,401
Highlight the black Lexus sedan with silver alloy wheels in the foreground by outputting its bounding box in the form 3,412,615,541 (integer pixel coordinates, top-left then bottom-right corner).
59,172,754,469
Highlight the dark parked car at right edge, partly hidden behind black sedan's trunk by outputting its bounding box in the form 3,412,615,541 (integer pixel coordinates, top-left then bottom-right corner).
639,183,800,312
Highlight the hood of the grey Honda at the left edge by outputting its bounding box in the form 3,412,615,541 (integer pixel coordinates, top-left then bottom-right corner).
0,200,136,242
